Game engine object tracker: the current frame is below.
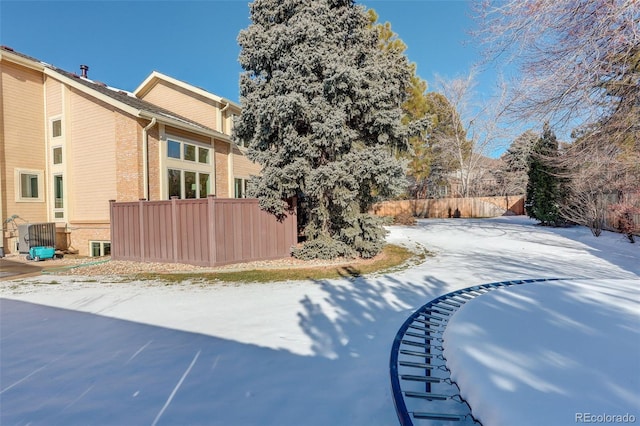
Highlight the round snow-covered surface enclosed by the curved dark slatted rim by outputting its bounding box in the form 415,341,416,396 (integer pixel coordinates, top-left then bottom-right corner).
445,280,640,425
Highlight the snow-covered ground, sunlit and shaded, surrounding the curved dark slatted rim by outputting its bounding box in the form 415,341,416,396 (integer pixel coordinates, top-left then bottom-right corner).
0,217,640,426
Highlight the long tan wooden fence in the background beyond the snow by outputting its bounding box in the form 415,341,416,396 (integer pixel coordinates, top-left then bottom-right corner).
372,195,524,218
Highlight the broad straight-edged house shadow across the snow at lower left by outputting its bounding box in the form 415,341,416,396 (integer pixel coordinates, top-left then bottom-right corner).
0,299,380,425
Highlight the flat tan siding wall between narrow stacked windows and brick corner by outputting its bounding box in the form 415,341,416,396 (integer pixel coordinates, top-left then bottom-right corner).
67,90,117,223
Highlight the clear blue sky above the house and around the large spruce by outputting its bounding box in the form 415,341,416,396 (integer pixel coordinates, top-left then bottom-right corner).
0,0,491,101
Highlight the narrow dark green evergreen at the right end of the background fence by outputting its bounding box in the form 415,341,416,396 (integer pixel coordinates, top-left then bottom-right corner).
525,123,562,226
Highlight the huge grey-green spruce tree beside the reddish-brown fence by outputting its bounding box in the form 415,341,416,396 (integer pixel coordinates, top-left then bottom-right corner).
235,0,411,258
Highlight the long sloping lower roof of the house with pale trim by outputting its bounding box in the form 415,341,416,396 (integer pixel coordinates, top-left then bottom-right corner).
0,46,229,140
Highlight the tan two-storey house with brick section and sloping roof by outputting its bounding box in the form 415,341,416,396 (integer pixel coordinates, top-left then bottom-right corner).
0,46,260,256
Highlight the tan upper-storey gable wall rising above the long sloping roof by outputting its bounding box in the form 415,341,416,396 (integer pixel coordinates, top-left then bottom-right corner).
143,81,219,130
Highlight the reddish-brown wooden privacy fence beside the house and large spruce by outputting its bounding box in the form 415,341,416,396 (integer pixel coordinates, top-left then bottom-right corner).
110,196,297,266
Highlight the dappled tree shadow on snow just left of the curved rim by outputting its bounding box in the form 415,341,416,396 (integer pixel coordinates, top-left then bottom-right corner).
298,275,447,370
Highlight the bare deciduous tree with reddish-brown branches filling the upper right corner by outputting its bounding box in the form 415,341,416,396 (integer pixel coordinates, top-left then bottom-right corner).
477,0,640,240
